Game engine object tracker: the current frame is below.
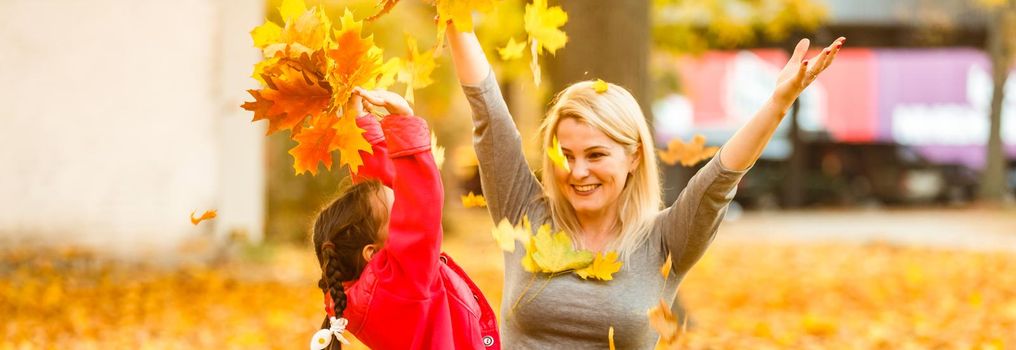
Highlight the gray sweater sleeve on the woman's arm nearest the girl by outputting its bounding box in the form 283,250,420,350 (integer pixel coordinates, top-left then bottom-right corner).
462,71,543,225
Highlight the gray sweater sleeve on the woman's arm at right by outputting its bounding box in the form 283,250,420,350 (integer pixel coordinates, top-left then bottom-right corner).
656,150,748,276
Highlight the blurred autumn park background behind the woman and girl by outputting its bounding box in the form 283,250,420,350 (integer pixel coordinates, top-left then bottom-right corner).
0,0,1016,349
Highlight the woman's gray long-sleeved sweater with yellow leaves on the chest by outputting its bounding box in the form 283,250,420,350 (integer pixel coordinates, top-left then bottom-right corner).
462,72,745,349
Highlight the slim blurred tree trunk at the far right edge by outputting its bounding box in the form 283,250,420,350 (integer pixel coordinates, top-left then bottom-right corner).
979,1,1016,203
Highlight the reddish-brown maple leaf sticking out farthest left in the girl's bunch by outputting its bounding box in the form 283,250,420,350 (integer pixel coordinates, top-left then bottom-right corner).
241,60,331,134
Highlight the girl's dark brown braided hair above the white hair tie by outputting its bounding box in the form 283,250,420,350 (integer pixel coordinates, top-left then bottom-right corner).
312,181,387,349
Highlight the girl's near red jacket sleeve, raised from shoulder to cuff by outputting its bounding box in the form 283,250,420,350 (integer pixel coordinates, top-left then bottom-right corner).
381,115,444,296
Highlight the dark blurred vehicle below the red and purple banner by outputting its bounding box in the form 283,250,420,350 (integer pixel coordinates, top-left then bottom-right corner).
735,141,978,209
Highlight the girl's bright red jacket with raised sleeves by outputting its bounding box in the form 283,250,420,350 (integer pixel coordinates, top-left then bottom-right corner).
335,115,501,349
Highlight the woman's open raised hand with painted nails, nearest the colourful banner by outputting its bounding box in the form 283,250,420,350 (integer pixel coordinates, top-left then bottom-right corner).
772,37,846,110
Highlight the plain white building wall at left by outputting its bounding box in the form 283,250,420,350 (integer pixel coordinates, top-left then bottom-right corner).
0,0,265,257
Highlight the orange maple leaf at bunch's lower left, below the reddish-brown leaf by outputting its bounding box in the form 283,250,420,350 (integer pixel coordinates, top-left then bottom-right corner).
290,114,336,175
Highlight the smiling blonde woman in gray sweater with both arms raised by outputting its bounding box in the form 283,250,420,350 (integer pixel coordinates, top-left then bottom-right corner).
448,22,845,349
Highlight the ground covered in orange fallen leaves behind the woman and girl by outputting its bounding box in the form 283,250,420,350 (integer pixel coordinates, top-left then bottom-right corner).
0,209,1016,349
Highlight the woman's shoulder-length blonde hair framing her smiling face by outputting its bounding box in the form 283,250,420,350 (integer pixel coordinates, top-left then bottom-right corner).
539,81,662,261
